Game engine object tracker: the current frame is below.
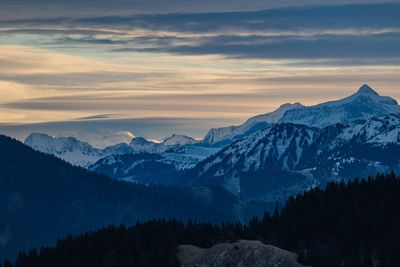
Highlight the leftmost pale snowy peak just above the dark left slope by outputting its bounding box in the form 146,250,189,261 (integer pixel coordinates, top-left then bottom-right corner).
25,133,133,167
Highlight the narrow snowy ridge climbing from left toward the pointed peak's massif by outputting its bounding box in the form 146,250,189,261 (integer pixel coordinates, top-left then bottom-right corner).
203,103,304,144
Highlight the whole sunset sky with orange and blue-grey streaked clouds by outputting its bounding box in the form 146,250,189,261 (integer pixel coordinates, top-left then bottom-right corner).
0,0,400,146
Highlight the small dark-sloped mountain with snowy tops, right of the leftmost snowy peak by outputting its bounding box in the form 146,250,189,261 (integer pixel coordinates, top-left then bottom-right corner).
89,134,209,181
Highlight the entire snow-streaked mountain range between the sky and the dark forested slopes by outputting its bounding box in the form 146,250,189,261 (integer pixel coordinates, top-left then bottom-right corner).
25,85,400,201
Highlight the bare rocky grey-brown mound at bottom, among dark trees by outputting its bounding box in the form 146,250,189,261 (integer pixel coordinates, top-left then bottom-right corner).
178,240,303,267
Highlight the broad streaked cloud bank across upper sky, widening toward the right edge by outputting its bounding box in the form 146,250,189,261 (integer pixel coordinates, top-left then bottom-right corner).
2,3,400,63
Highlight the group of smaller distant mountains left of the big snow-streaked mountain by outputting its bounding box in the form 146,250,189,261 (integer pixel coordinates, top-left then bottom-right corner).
25,133,214,185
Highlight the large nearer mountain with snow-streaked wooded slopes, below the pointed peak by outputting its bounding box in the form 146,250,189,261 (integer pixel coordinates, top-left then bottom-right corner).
182,114,400,201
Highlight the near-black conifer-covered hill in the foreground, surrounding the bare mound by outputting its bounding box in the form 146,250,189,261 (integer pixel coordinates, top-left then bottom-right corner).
4,174,400,267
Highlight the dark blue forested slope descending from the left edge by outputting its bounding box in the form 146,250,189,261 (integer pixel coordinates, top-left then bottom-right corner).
0,136,263,259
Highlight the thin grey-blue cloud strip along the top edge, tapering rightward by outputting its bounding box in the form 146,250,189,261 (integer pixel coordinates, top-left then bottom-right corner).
0,0,390,19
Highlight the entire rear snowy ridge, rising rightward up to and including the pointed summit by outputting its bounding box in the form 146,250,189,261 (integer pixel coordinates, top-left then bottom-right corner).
203,84,400,145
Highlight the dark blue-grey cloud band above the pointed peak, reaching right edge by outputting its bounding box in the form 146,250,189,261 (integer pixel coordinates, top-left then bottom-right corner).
162,33,400,61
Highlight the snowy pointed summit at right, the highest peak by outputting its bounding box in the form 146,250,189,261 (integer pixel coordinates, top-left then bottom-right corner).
279,84,400,127
